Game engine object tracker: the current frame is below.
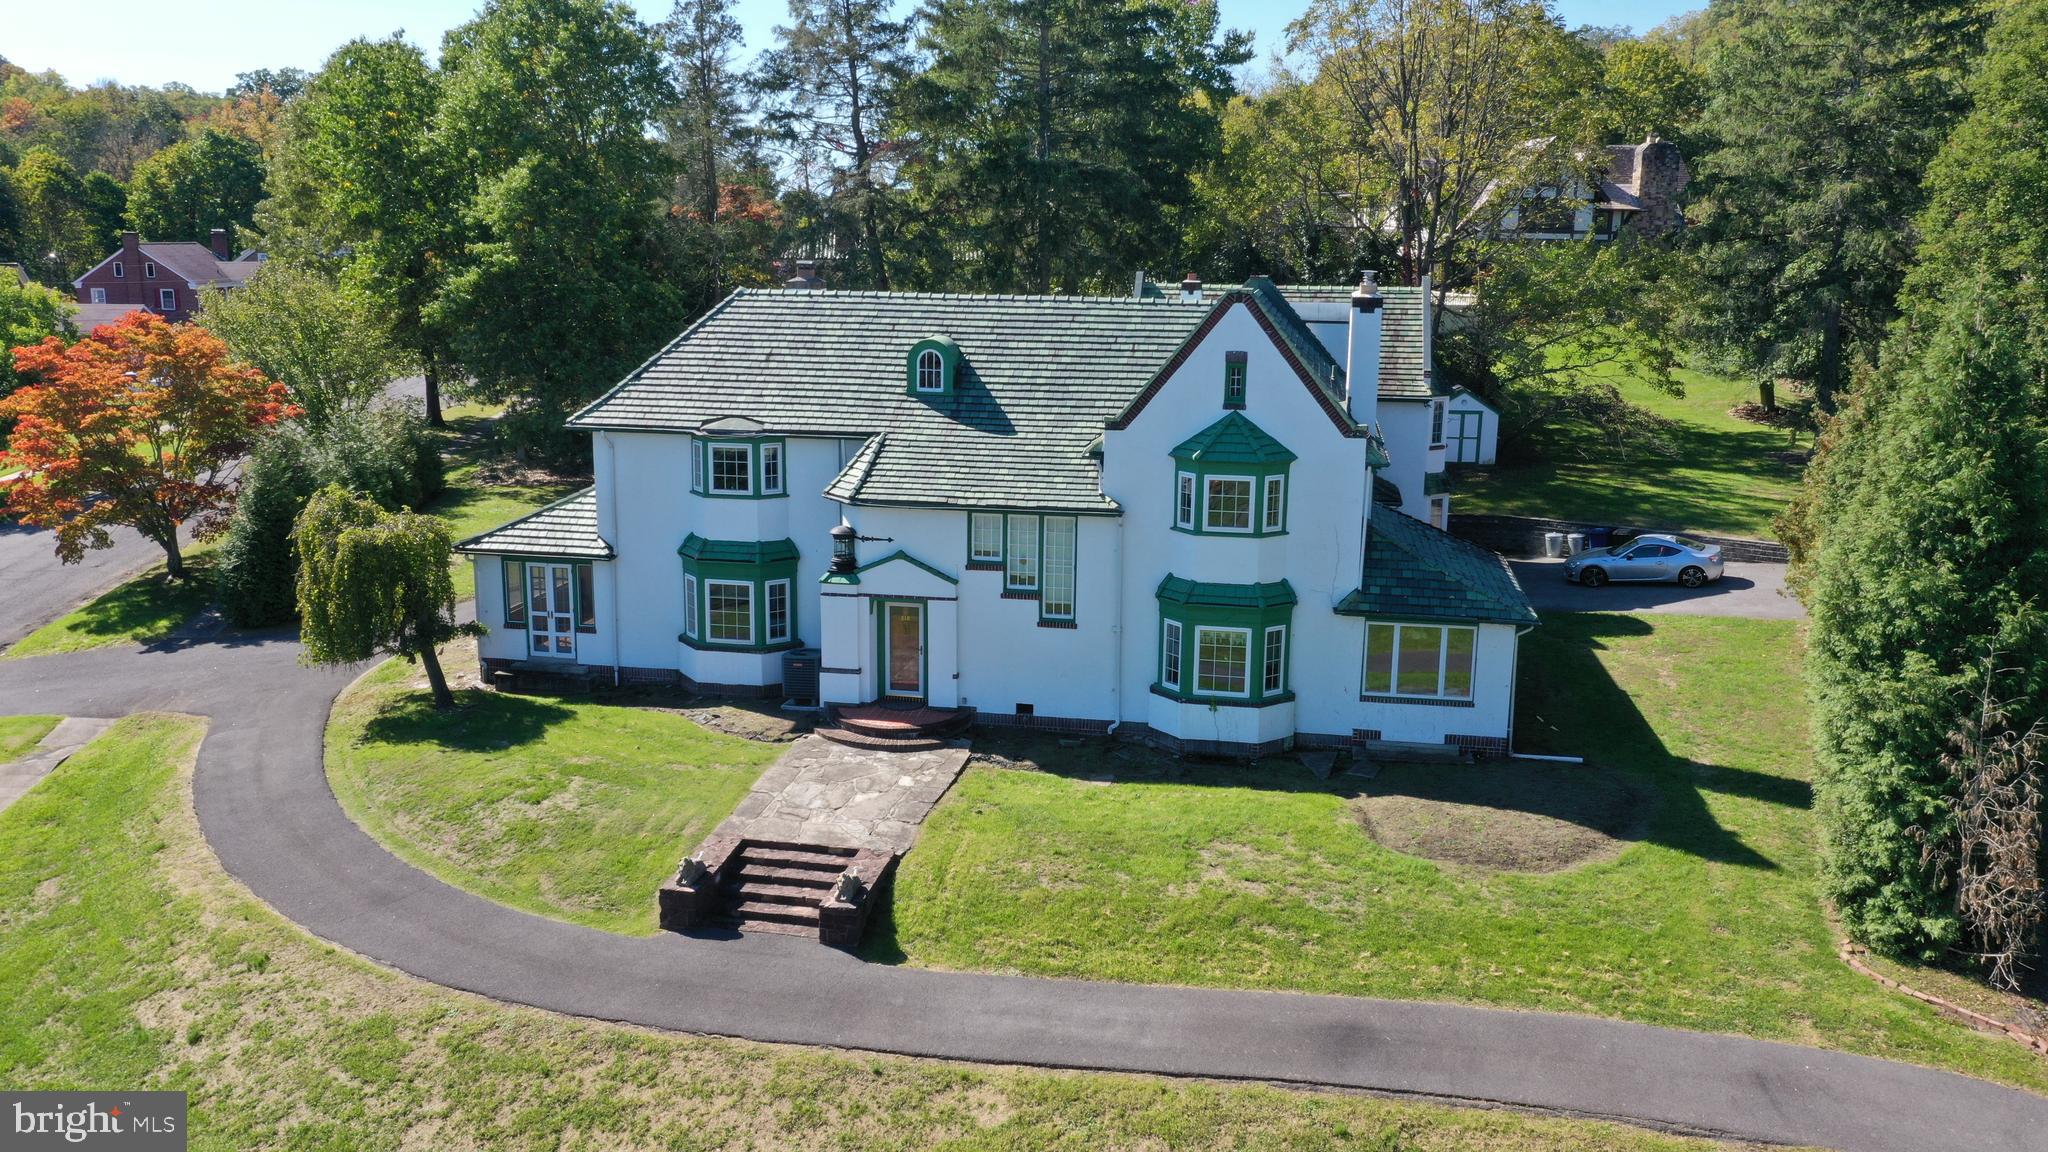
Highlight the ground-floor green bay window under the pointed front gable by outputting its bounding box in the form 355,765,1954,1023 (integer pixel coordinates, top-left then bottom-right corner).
1153,576,1294,707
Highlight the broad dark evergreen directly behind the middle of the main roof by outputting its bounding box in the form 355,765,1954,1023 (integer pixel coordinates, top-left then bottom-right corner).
901,0,1251,293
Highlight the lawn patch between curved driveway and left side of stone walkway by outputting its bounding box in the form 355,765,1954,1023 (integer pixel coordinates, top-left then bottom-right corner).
328,646,782,933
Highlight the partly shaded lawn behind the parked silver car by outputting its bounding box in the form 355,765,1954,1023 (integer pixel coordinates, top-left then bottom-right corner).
1452,358,1812,537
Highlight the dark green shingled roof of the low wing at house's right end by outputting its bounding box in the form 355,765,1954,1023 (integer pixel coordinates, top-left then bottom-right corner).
1337,504,1536,625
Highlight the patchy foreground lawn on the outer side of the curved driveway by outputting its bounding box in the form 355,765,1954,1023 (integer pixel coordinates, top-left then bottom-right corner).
0,715,1777,1152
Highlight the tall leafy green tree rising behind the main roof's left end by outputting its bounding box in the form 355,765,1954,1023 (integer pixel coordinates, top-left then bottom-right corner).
430,0,684,459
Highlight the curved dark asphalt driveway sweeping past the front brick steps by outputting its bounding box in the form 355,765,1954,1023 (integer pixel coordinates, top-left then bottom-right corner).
0,635,2048,1152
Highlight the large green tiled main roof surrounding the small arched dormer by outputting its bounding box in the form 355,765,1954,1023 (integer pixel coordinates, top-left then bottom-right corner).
569,289,1210,512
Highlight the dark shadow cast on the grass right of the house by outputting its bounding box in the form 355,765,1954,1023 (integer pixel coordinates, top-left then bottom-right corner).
1516,613,1812,869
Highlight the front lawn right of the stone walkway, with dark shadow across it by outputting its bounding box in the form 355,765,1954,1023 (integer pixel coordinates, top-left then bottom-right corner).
868,615,2048,1088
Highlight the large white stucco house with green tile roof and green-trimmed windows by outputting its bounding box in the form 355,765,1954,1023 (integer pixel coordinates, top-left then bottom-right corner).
459,268,1536,752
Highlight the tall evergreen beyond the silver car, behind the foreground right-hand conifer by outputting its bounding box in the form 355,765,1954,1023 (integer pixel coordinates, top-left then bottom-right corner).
1692,0,1982,412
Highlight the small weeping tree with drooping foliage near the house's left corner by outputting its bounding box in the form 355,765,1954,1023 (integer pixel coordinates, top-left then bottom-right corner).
293,484,477,707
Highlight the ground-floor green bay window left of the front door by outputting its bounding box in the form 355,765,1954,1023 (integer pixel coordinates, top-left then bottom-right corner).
676,533,803,652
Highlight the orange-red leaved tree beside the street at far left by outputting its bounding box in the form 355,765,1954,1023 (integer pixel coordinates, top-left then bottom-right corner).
0,312,295,578
